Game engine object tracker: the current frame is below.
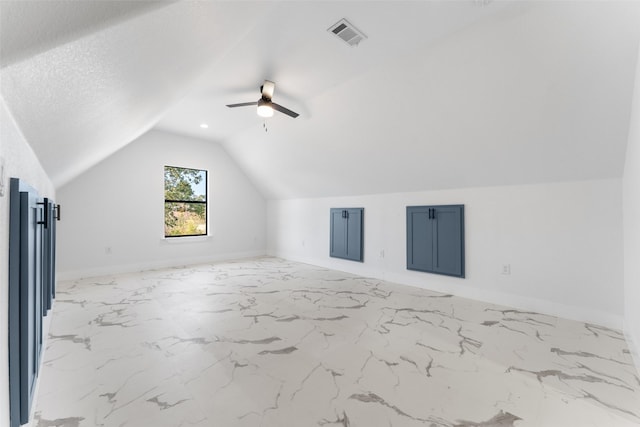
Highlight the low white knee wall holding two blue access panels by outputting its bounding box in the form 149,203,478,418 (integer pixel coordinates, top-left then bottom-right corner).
267,179,623,329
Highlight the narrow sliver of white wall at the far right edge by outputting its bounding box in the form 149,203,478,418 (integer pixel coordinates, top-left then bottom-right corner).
623,42,640,370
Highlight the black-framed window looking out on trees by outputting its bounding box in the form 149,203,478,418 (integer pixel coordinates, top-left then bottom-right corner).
164,166,207,237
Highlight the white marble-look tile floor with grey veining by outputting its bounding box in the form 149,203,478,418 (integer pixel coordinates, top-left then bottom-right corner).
31,258,640,427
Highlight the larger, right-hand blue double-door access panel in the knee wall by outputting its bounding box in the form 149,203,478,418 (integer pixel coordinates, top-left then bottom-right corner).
407,205,465,277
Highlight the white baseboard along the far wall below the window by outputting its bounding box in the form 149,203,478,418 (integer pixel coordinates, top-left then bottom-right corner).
56,250,265,281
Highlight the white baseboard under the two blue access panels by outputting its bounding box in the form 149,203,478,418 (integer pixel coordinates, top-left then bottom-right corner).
269,251,624,330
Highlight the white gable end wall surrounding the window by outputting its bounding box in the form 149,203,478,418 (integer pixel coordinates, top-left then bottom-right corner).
58,131,266,278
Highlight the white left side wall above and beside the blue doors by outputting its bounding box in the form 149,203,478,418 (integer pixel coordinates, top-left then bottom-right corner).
0,98,55,426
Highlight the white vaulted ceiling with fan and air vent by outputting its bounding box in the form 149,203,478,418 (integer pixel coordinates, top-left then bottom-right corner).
0,0,640,198
